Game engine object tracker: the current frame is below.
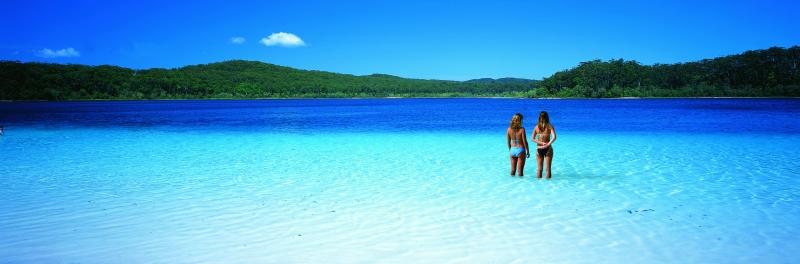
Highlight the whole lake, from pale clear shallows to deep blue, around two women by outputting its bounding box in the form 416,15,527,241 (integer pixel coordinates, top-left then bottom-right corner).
0,99,800,263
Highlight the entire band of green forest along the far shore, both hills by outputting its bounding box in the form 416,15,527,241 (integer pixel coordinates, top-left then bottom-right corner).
0,46,800,100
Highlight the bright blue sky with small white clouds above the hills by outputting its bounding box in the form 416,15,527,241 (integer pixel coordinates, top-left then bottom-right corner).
0,0,800,80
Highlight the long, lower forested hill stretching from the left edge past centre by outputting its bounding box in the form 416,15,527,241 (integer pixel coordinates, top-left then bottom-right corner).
0,60,536,100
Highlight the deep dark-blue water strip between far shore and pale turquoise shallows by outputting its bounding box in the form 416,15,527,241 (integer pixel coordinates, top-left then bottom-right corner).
0,99,800,134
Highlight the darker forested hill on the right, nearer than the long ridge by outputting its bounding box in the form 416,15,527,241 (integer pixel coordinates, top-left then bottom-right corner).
528,46,800,97
